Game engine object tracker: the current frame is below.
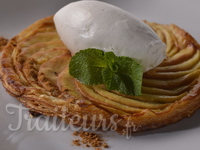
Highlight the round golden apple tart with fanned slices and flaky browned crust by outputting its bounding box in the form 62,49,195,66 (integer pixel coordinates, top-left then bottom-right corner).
0,16,200,132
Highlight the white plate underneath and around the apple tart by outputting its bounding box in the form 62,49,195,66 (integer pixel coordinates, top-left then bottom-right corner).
0,0,200,150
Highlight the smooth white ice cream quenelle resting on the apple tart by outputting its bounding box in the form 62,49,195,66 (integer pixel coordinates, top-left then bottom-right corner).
54,1,166,72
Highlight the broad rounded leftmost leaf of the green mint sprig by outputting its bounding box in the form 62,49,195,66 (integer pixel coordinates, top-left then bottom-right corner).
69,49,107,85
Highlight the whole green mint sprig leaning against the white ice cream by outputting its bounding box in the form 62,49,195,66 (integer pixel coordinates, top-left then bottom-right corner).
69,48,143,95
